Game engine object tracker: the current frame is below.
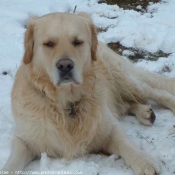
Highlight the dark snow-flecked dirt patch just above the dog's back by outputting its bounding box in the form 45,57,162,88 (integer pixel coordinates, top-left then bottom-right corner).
108,42,170,62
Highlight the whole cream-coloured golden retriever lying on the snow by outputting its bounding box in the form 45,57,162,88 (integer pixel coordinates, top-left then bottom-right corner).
3,13,175,175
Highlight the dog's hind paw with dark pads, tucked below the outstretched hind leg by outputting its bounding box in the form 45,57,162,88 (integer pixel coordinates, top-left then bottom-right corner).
129,103,156,125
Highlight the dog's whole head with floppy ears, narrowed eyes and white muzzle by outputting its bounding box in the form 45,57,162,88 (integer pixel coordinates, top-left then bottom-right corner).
23,13,97,86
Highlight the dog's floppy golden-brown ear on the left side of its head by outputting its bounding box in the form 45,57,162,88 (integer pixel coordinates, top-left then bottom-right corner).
23,17,38,64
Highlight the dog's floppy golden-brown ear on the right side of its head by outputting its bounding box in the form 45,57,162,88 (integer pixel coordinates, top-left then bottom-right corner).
78,13,98,61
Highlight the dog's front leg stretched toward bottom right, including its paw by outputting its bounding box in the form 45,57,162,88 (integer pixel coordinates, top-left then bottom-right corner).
106,123,159,175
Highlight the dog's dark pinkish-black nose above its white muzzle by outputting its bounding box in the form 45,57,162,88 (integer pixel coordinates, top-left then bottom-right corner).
56,58,74,73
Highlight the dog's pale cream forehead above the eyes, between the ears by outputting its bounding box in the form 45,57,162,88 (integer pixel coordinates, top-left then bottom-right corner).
37,13,89,36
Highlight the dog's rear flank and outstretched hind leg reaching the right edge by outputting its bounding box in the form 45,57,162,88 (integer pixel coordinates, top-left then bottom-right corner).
99,42,175,114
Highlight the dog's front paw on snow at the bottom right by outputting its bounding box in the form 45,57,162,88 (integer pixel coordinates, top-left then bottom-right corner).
131,154,159,175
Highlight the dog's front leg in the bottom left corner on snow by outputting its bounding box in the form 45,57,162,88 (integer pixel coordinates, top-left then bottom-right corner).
2,135,34,174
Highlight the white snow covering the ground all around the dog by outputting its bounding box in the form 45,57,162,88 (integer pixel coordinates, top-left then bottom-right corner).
0,0,175,175
